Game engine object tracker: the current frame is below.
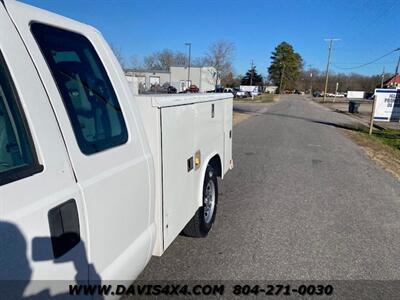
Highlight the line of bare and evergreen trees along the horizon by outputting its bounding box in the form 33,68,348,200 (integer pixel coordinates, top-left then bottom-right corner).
112,40,392,93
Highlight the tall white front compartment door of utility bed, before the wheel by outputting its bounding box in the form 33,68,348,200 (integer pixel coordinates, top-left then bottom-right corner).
161,104,198,249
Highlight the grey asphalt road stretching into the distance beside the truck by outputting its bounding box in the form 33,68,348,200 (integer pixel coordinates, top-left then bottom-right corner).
139,96,400,280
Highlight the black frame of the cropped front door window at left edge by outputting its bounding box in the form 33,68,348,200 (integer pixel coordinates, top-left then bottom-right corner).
0,50,44,187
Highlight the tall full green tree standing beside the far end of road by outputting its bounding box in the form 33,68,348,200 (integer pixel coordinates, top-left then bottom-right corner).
268,42,303,90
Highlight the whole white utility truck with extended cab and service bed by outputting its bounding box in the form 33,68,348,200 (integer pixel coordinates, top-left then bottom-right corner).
0,0,233,296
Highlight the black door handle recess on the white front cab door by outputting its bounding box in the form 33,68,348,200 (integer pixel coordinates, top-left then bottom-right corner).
48,199,81,258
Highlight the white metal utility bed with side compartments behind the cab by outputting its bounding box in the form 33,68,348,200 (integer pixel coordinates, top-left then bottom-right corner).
134,94,233,255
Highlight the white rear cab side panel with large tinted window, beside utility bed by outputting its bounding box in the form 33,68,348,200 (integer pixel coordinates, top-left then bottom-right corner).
5,1,155,279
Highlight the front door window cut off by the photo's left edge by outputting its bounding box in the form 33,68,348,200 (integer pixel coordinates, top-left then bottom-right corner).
0,53,41,185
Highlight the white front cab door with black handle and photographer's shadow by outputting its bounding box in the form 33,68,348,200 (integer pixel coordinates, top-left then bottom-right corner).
0,2,88,299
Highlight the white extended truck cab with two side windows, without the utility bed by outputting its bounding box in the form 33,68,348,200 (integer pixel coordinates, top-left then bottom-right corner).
0,1,155,292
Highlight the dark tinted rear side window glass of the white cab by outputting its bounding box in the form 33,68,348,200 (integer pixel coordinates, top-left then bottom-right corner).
31,23,128,154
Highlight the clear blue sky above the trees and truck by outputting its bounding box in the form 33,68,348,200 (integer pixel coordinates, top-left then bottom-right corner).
22,0,400,76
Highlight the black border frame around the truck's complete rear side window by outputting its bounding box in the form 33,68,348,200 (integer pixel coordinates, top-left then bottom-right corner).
29,21,129,156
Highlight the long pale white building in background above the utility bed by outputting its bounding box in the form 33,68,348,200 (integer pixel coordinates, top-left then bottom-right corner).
126,67,220,93
